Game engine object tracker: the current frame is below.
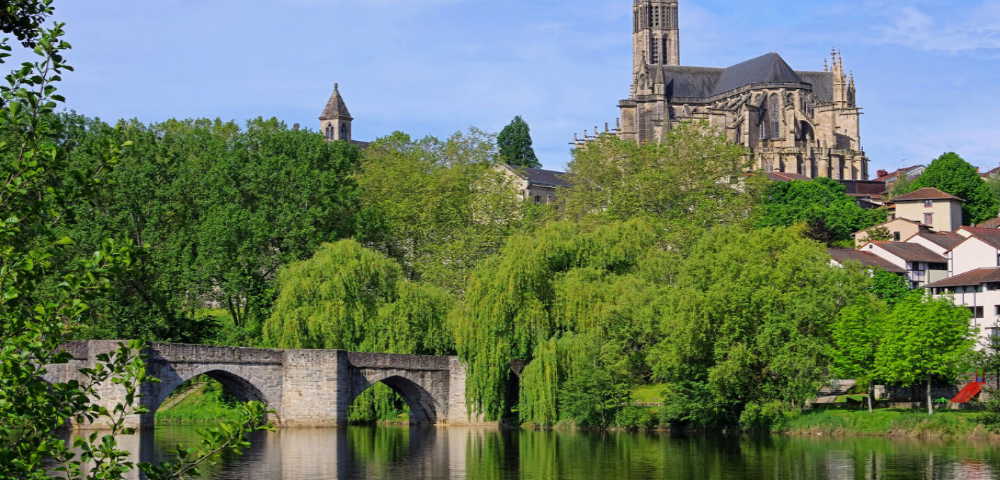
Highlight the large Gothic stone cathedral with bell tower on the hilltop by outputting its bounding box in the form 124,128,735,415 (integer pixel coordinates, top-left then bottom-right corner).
574,0,868,180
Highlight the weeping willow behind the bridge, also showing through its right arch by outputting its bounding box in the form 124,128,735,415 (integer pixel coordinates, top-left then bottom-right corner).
264,240,454,421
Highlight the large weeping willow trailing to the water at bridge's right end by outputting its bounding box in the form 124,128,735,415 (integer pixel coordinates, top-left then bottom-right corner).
452,219,670,424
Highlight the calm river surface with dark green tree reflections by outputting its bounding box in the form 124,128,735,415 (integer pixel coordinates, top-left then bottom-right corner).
109,427,1000,480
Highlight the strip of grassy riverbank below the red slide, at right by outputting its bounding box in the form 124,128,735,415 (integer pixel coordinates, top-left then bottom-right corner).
781,409,992,437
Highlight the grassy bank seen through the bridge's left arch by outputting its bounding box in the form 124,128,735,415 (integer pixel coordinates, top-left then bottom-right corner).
156,379,240,425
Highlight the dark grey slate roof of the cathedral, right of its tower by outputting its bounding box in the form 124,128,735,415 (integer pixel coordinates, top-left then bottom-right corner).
647,53,833,102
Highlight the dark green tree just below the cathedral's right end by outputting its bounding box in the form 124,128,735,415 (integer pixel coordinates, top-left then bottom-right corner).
757,178,886,245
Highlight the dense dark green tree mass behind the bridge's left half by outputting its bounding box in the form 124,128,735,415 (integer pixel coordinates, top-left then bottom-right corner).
51,114,360,343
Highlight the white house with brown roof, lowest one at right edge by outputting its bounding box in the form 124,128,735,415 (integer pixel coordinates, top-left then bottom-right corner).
924,267,1000,345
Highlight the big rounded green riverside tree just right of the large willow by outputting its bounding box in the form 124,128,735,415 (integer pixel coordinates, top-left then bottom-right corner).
650,227,868,428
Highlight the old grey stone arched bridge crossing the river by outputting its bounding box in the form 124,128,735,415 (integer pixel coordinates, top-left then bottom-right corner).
45,340,482,427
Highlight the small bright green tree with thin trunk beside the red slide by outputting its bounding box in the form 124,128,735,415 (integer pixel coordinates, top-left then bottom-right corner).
876,292,974,414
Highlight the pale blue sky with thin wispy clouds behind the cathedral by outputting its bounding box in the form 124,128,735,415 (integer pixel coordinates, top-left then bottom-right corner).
55,0,1000,176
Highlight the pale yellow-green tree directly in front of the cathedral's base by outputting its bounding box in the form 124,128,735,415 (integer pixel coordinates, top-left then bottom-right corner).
564,122,765,248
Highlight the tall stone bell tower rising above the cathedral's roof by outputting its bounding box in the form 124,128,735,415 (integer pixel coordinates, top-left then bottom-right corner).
632,0,681,75
